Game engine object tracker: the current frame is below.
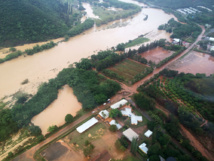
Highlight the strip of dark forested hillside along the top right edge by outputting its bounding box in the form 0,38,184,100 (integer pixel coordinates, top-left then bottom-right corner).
137,0,214,9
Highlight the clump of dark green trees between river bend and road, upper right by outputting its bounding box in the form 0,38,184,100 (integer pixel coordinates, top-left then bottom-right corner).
158,18,202,43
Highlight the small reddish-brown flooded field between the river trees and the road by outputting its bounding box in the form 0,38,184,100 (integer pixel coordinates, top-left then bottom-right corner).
140,47,173,64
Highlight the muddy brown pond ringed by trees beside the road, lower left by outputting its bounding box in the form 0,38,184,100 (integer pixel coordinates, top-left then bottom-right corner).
31,85,82,135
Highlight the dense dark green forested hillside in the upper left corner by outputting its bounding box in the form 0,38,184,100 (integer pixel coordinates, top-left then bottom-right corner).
0,0,72,46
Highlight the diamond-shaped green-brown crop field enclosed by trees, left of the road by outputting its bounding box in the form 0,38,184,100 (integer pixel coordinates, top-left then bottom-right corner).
110,59,148,82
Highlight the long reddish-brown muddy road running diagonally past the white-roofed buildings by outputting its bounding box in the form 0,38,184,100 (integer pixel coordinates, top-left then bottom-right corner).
14,26,205,161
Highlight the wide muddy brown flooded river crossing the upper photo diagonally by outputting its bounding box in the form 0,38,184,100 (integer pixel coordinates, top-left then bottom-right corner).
0,0,174,98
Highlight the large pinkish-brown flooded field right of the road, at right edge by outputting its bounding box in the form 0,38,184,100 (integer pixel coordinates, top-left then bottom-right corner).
167,51,214,76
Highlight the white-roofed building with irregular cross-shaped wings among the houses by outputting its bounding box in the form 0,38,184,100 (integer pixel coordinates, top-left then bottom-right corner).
121,108,143,125
